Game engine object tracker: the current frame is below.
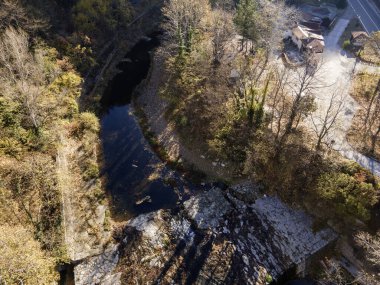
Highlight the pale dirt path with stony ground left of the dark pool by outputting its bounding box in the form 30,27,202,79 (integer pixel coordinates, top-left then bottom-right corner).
56,128,109,261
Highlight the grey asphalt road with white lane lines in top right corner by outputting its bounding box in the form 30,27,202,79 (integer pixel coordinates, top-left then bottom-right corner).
348,0,380,34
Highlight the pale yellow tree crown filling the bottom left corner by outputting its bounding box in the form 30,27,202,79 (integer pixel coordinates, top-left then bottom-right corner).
0,225,58,285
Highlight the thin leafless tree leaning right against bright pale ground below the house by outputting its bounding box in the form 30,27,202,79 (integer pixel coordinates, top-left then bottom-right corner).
310,87,345,151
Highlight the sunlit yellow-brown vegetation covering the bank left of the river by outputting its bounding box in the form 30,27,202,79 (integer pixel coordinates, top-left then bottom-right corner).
0,0,117,284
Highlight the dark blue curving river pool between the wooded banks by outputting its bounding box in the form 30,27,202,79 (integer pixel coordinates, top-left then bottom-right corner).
101,33,214,218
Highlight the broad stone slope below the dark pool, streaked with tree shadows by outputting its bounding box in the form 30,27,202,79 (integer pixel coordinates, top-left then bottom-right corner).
74,183,336,284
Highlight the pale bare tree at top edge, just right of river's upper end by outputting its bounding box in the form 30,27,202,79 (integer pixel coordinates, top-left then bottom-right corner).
162,0,210,57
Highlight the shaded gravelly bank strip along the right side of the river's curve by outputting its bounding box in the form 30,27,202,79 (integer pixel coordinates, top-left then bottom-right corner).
135,48,236,182
